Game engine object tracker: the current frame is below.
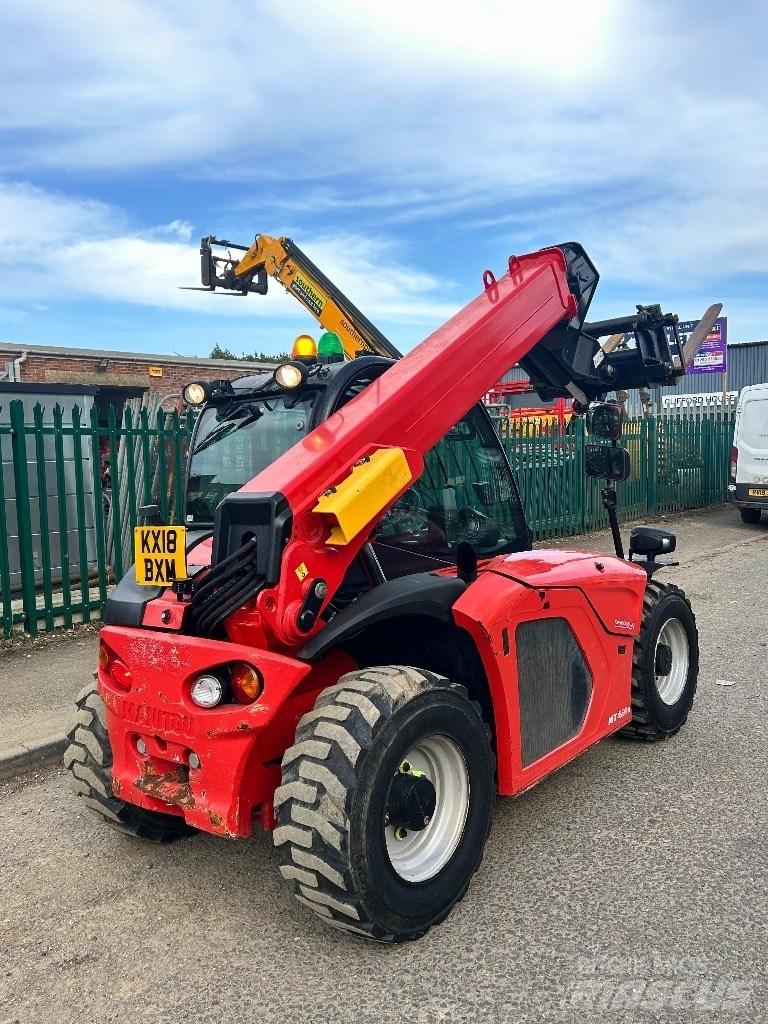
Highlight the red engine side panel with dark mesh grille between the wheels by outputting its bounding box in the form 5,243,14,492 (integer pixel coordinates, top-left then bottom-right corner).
454,566,645,796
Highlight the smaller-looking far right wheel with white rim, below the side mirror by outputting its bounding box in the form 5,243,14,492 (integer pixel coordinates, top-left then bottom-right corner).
621,580,698,740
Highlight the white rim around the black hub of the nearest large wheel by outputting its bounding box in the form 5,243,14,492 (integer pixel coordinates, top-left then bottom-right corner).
384,736,469,882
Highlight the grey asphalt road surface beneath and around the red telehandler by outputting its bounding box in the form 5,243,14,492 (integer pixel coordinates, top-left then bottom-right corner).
0,512,768,1024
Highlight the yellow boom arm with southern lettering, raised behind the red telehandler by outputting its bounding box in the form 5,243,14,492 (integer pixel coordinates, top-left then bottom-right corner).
200,234,400,359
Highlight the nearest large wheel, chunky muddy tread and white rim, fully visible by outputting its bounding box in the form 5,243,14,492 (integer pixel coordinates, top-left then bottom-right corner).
273,666,495,942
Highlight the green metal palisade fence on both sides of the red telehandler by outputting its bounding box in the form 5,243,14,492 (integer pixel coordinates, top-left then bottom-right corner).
0,400,733,636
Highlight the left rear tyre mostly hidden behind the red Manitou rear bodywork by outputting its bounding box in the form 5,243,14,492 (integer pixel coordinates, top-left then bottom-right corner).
63,683,196,843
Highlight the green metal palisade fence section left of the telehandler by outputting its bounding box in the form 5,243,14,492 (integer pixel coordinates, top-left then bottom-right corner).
0,400,191,637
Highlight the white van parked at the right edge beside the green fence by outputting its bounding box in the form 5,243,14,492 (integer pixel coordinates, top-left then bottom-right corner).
728,384,768,522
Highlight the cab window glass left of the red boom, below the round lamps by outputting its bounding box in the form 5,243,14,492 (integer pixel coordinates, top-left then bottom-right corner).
186,391,316,524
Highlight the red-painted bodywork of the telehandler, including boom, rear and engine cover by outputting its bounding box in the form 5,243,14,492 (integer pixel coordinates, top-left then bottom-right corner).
98,249,646,837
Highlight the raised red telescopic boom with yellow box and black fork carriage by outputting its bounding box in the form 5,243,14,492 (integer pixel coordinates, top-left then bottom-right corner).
193,240,720,650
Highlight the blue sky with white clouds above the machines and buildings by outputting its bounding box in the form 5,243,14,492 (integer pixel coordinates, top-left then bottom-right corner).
0,0,768,355
